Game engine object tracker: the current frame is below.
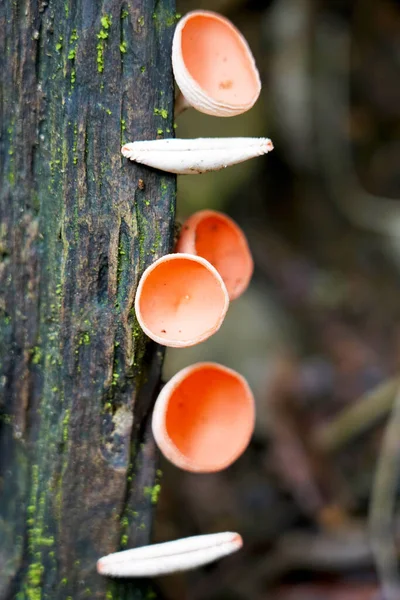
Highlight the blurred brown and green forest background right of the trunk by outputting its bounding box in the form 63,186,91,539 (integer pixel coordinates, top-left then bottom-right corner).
155,0,400,600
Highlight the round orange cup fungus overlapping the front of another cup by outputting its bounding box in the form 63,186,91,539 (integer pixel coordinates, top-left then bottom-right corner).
135,254,229,348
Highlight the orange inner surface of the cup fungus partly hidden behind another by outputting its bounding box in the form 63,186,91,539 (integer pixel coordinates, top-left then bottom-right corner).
195,216,252,295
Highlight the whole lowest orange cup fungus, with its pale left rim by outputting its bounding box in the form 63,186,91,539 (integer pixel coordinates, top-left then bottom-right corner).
152,362,255,473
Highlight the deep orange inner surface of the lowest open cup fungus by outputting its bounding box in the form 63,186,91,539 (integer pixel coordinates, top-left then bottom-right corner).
166,367,254,470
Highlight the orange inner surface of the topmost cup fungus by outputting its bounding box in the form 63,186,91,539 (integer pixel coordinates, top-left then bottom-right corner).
182,15,259,106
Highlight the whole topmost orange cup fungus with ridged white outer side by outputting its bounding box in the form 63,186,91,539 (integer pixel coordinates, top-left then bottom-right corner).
172,10,261,117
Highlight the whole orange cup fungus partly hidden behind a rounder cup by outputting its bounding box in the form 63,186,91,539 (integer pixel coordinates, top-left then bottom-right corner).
176,210,254,300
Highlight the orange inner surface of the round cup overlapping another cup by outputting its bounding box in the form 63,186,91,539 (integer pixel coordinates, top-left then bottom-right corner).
139,258,225,342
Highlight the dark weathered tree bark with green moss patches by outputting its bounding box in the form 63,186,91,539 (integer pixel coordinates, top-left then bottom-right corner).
0,0,175,600
